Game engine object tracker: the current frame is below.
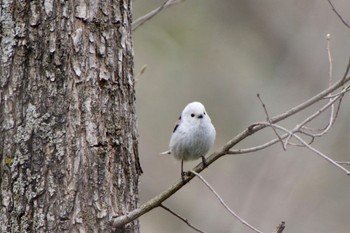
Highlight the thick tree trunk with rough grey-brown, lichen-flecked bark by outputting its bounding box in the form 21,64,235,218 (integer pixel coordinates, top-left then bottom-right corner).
0,0,141,232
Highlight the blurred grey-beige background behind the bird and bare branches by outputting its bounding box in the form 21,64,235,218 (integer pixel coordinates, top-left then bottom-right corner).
133,0,350,233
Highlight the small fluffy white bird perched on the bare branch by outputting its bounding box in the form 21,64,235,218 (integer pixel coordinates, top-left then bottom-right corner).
161,102,216,179
